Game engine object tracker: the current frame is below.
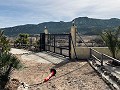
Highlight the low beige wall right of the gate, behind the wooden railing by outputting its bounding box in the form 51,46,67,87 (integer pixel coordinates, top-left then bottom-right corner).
75,47,120,59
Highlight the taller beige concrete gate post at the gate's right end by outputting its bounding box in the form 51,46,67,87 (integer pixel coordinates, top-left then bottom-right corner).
71,22,77,59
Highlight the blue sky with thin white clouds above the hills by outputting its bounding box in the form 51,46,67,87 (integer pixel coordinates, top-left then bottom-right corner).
0,0,120,28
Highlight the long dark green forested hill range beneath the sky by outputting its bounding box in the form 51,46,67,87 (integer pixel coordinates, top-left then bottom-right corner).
1,17,120,36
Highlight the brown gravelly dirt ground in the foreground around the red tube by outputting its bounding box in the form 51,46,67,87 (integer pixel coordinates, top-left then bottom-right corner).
11,55,110,90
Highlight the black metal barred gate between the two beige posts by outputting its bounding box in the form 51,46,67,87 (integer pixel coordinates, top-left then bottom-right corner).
40,33,71,58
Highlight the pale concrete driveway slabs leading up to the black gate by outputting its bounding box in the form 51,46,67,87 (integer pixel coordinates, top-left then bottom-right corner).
10,48,68,64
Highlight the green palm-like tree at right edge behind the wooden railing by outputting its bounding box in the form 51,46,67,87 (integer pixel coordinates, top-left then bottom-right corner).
101,26,120,64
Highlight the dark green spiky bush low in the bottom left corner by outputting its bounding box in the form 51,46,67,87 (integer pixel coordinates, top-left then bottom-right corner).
0,53,22,89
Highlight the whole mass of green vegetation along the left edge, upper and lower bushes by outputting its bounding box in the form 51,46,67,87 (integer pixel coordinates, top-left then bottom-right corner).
0,31,21,90
